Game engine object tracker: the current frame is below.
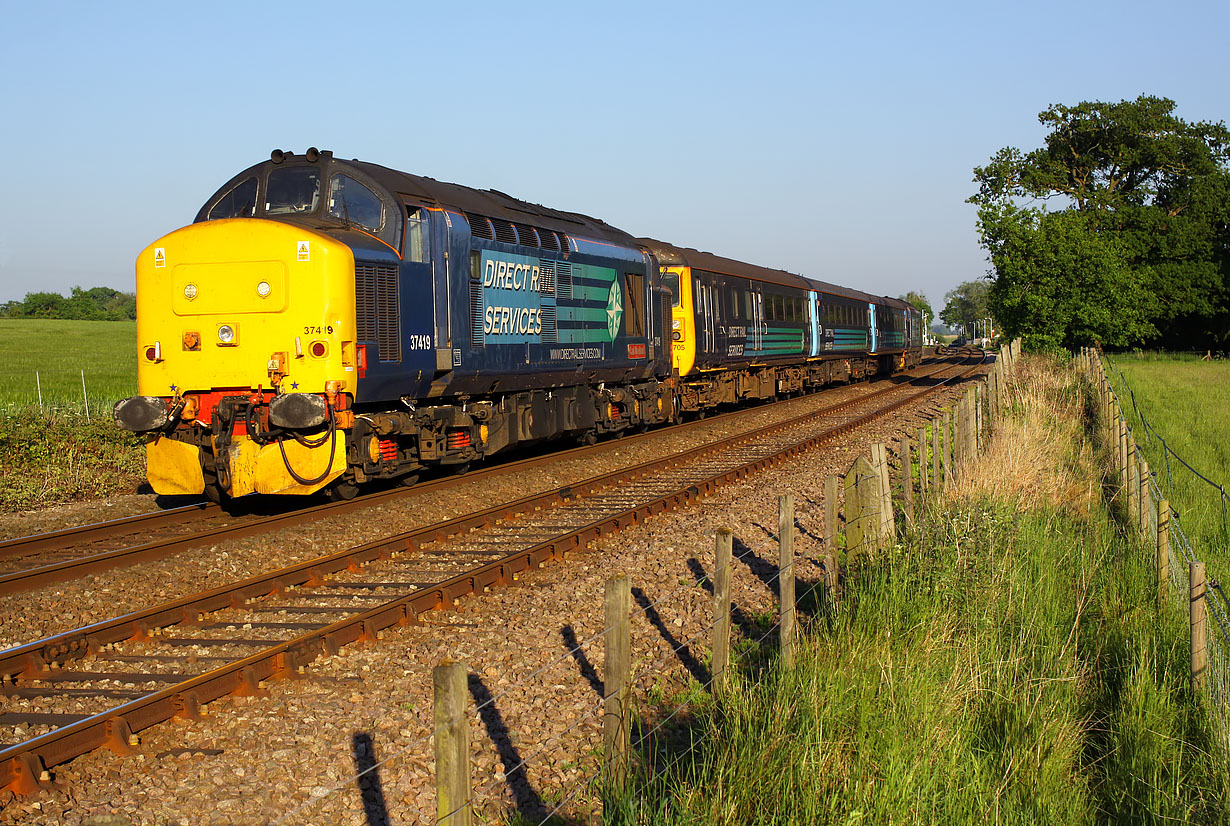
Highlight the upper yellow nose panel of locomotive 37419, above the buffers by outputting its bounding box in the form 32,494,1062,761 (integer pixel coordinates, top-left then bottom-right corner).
137,218,354,398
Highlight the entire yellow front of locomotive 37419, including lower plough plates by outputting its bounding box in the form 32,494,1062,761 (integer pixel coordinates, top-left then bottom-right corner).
132,218,355,497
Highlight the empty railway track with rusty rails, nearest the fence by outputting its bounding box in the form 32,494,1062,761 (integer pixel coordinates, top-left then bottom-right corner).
0,349,980,793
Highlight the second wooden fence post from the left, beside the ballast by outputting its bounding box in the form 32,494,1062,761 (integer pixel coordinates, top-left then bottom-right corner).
603,574,632,789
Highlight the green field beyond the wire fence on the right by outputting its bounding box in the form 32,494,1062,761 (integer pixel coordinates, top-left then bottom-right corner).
1107,354,1230,575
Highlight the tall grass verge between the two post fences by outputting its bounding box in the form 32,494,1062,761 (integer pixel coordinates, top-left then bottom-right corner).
608,360,1230,825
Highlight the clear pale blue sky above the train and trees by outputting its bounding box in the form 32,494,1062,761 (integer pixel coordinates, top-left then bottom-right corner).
0,0,1230,310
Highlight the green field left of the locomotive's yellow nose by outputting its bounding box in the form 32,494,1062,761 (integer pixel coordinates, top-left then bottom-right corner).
0,318,137,417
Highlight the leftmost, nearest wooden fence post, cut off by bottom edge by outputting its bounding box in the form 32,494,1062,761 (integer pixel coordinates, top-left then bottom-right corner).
432,660,472,826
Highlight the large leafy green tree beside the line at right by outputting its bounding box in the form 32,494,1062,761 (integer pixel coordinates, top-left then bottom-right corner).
969,96,1230,347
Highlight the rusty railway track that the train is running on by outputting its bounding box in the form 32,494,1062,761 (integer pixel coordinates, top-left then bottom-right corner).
0,351,942,595
